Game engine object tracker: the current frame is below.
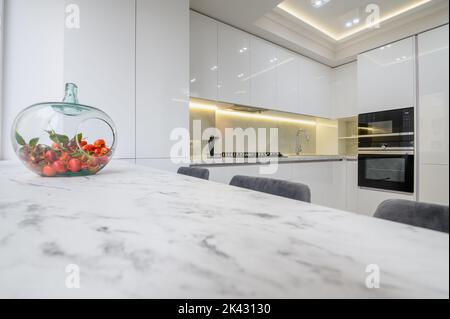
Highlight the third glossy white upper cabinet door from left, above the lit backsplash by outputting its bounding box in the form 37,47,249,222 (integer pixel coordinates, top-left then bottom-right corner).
250,37,278,109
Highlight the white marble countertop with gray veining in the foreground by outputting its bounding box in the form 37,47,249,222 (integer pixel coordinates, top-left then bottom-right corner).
0,161,449,298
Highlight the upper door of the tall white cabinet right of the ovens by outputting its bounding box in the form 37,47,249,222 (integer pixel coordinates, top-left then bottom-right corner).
417,25,449,165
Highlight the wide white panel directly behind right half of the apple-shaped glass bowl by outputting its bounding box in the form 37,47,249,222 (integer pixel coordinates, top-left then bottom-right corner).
61,0,135,158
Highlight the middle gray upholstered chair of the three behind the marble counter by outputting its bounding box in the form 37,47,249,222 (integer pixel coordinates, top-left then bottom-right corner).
230,175,311,203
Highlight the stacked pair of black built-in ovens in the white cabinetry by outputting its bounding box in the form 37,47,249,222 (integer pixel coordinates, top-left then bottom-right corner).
358,108,415,193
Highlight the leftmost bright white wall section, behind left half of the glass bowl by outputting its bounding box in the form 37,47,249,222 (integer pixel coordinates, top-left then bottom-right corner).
1,0,65,159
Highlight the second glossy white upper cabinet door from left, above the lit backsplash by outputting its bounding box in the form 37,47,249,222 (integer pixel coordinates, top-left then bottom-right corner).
218,23,250,105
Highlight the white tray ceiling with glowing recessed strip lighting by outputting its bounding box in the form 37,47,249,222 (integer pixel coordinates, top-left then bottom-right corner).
190,0,449,66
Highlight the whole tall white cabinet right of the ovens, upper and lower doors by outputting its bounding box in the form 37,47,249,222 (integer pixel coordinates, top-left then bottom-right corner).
417,25,449,205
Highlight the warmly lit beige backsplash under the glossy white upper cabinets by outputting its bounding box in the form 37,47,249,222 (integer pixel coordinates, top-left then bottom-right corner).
190,99,339,155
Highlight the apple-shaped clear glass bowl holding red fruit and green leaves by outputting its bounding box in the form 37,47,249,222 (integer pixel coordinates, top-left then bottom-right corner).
11,83,117,177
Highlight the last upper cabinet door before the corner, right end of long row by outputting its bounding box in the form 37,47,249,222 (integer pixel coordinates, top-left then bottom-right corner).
299,57,333,118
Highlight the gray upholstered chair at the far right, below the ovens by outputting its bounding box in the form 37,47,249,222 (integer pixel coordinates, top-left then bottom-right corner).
374,200,448,233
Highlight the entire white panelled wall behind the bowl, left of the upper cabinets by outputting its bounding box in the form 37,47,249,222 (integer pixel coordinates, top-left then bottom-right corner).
0,0,189,165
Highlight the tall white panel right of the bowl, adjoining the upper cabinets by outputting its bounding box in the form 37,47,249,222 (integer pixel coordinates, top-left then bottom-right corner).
136,0,189,159
